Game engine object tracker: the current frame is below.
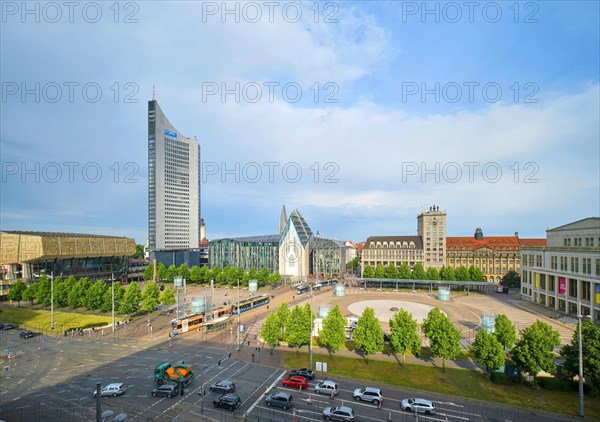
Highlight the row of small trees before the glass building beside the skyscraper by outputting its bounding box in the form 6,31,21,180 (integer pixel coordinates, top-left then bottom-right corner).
144,262,281,287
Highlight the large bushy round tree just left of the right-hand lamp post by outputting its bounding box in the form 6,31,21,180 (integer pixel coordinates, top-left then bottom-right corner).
510,320,560,377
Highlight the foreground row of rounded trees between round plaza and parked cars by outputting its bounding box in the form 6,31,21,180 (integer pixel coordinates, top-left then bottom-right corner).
261,303,600,388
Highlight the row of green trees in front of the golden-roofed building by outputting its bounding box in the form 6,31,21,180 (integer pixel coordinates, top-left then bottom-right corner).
8,275,175,315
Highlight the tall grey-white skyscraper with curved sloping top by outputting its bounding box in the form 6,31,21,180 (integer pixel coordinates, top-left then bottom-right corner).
148,99,200,256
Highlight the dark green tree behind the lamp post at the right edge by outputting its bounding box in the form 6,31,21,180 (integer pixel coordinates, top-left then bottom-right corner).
560,320,600,395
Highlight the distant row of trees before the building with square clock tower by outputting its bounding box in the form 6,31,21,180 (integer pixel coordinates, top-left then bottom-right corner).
363,262,485,281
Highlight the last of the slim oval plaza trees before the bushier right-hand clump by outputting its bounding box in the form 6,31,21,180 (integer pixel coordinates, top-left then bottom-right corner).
422,308,460,371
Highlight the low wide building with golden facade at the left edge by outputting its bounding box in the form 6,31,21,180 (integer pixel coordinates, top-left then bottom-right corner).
0,231,136,300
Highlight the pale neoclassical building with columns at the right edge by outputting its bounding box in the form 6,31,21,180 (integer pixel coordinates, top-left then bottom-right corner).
521,217,600,323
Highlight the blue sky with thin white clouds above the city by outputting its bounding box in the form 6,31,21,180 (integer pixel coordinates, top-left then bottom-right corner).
0,1,600,243
